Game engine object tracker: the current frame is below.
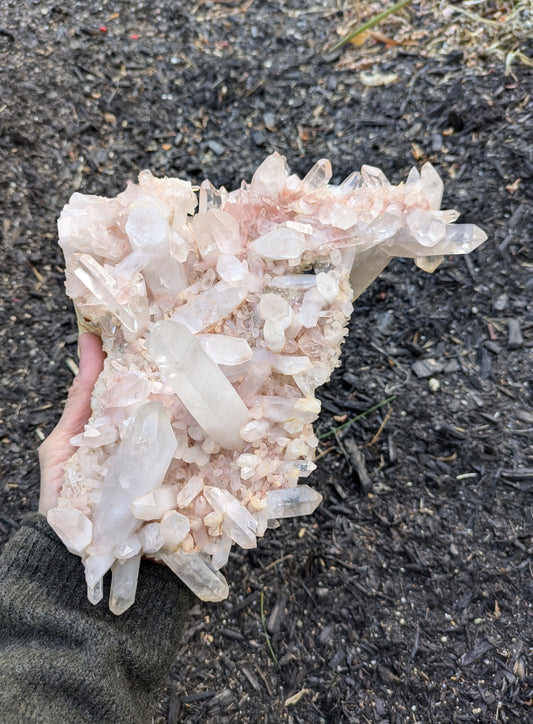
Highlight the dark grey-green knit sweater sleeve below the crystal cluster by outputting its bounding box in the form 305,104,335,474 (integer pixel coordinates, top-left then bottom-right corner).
0,514,195,724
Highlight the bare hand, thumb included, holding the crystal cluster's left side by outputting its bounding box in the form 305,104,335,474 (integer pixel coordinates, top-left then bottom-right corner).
39,333,105,515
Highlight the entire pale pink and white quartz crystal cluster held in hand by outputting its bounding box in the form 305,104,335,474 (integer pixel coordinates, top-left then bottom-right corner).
48,154,485,614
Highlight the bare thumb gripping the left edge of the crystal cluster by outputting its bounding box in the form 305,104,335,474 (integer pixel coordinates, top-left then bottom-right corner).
57,332,105,439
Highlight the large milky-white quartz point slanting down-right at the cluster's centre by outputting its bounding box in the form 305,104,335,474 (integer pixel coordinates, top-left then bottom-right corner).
146,320,250,450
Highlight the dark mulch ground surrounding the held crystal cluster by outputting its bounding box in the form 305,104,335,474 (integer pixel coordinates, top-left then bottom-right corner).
0,0,533,724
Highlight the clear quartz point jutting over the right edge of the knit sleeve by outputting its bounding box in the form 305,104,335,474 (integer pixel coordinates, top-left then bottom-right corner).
161,551,229,601
